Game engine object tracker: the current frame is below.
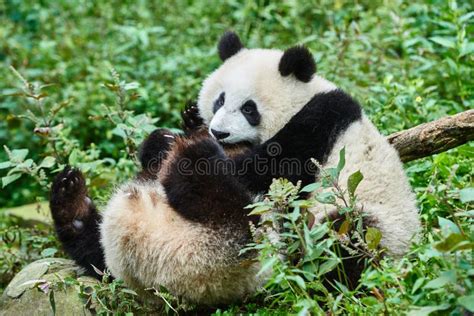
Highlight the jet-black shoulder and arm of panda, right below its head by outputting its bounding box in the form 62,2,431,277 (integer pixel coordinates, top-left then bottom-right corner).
236,90,362,193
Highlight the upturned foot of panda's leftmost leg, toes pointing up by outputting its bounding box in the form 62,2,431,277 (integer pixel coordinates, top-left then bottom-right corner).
50,166,93,226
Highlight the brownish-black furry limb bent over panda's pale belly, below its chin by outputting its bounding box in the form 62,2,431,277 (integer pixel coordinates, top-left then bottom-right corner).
160,136,257,229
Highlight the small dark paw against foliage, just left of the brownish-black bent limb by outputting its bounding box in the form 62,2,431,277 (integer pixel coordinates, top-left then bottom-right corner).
138,128,177,175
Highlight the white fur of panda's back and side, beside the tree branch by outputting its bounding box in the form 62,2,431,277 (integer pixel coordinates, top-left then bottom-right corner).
312,115,420,256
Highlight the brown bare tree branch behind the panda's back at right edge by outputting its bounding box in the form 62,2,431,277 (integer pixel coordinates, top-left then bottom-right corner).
387,110,474,162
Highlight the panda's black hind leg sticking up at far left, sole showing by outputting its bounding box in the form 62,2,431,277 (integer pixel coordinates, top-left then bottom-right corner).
50,167,105,277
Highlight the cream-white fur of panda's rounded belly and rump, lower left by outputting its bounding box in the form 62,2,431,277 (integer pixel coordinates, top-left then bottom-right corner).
101,182,263,305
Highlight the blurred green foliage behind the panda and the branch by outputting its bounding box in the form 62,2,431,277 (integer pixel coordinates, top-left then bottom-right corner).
0,0,474,314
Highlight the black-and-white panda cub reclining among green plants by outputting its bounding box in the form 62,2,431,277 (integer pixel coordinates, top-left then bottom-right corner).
50,32,420,305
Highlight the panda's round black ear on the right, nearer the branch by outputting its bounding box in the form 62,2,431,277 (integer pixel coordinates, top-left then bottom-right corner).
278,46,316,82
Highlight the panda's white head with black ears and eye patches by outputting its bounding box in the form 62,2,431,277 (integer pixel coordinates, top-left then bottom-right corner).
198,32,336,144
